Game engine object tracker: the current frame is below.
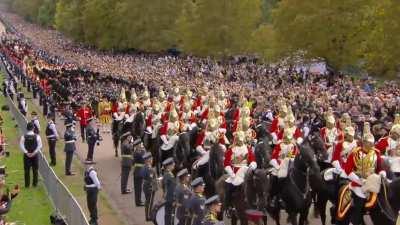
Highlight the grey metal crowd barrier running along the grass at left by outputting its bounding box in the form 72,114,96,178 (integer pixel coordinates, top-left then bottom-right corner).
1,62,89,225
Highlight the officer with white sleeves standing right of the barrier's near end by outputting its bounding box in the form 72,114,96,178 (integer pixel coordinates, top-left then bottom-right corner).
84,166,101,225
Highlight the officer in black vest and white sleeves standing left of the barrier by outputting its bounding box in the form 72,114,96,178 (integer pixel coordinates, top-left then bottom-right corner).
19,122,42,187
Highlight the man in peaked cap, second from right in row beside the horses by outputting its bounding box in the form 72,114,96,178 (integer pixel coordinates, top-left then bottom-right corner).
188,177,206,225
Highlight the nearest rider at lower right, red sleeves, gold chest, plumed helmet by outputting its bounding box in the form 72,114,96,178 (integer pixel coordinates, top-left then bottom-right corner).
345,123,386,225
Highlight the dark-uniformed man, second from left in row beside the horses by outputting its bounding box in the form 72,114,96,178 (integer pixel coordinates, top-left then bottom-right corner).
132,142,146,206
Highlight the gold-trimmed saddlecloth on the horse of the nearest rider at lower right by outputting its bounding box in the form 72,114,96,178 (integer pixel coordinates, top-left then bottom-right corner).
336,184,378,221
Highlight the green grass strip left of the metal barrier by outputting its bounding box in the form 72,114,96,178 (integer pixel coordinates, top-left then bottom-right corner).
0,83,53,225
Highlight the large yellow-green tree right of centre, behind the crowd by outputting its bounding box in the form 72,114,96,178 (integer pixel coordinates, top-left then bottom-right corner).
272,0,372,69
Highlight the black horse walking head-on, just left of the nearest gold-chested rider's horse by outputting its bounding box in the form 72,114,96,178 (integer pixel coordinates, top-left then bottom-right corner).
268,139,321,225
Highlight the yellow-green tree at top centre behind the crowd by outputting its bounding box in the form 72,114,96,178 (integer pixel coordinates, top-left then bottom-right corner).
178,0,261,57
